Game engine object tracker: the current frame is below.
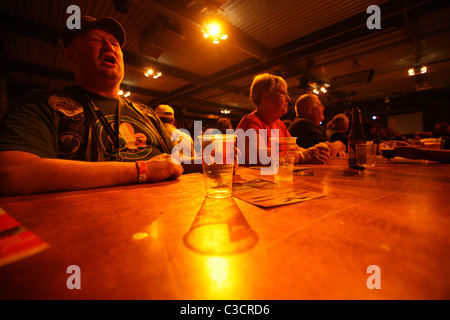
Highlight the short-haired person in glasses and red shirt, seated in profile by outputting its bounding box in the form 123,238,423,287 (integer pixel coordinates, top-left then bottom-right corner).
236,73,330,165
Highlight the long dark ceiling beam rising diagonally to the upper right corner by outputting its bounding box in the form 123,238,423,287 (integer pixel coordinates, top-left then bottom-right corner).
150,0,450,103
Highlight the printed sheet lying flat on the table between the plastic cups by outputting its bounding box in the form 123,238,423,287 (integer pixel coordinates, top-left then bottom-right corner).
233,179,325,208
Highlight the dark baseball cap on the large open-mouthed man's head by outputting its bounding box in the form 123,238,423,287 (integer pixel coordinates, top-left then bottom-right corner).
62,16,126,48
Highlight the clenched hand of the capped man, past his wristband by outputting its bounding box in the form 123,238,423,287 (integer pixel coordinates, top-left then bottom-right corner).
145,153,183,182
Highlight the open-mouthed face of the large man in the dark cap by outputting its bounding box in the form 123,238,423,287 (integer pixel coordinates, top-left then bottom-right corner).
69,29,124,84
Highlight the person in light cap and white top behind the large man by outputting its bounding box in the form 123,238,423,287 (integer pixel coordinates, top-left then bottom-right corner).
155,104,194,157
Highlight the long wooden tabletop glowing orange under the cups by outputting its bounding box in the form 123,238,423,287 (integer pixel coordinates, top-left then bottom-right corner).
0,158,450,300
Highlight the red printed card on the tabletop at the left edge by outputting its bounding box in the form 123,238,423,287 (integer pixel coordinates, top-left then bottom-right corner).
0,208,48,267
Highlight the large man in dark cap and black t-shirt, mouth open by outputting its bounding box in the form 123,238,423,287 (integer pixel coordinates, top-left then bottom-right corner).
0,17,183,196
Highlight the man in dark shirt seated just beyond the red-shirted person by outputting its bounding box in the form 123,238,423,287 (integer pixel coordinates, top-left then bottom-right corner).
289,94,346,157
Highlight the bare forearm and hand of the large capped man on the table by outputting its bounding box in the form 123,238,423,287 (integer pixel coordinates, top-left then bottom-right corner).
0,151,183,196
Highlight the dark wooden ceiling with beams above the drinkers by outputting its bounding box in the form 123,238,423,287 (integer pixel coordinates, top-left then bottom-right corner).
0,0,450,124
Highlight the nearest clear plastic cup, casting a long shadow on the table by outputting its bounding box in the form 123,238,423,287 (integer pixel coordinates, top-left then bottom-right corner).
199,134,236,199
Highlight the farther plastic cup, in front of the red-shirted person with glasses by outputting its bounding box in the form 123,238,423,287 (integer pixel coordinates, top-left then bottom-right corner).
270,137,297,181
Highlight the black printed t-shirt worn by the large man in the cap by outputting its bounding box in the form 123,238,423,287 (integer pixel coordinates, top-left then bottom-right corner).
0,87,173,161
